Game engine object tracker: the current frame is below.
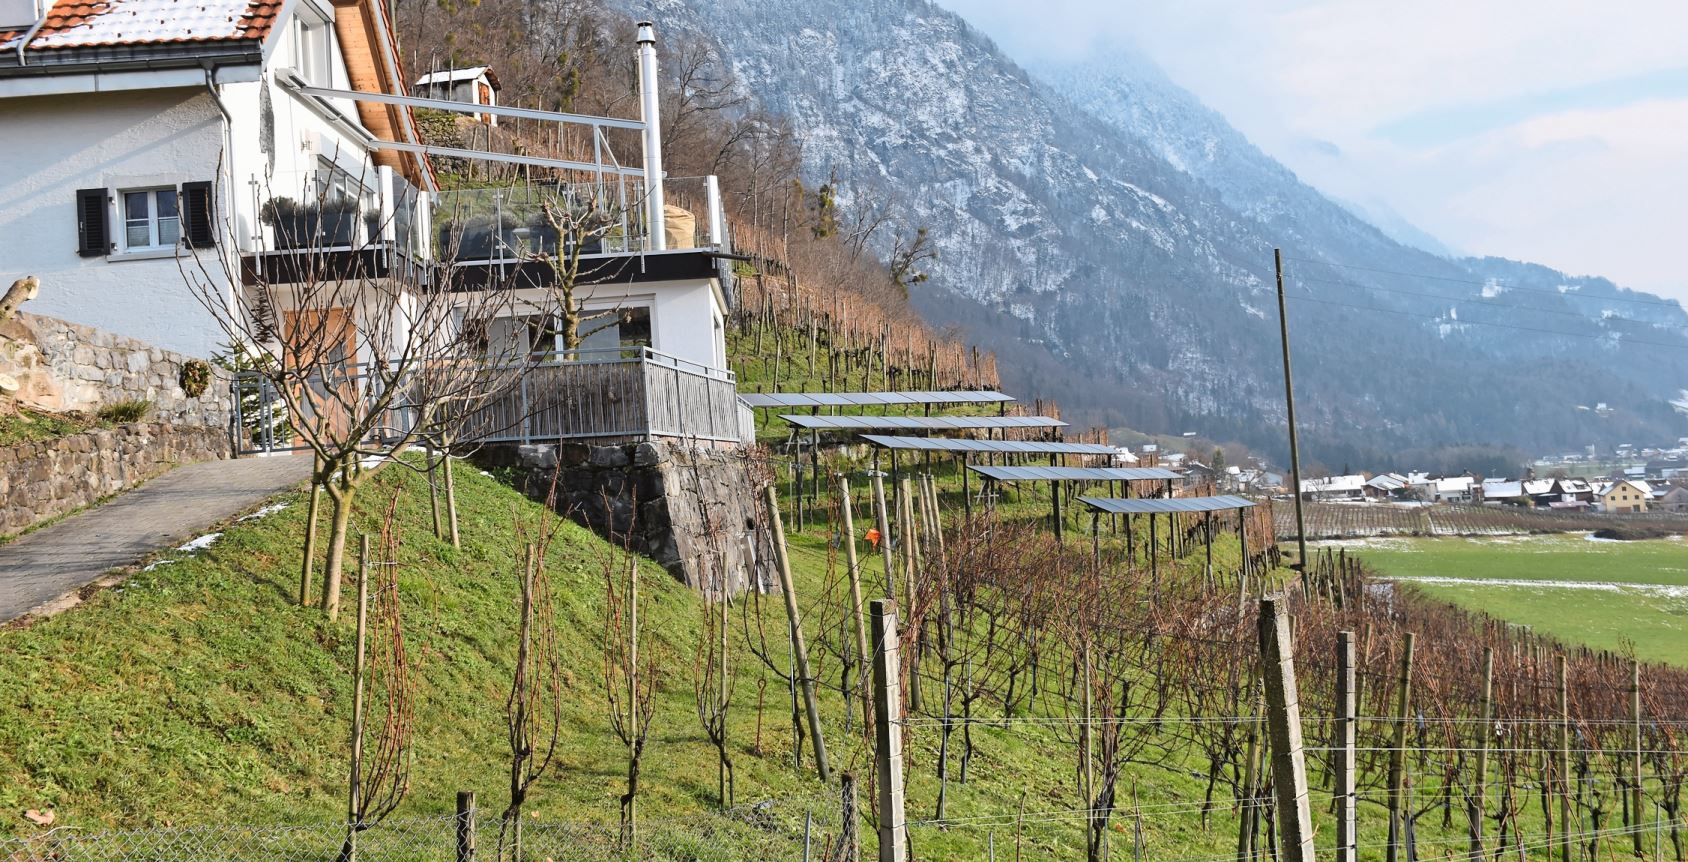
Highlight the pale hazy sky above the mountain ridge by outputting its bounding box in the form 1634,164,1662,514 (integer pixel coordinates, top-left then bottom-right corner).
939,0,1688,299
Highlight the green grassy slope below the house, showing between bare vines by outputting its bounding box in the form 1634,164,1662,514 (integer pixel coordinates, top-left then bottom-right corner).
0,323,1640,859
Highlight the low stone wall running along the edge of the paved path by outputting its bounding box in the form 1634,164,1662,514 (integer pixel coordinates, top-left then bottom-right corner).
0,422,228,536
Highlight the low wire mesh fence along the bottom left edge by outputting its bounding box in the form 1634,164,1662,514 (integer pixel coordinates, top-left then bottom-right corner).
0,796,842,862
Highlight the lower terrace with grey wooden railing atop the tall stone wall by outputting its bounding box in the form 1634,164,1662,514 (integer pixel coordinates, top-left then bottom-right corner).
463,347,753,445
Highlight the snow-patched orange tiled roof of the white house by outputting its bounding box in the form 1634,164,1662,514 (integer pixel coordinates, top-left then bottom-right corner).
0,0,282,51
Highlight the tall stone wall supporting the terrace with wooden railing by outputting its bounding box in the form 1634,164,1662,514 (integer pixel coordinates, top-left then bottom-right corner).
481,442,778,594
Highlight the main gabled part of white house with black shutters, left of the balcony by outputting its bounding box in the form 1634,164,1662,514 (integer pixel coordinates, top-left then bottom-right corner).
0,0,434,356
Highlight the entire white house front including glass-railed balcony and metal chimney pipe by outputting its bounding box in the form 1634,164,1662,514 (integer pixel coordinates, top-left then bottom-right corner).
0,0,743,440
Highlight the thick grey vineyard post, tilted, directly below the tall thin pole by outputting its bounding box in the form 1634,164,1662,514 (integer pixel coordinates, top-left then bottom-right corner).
1259,597,1313,862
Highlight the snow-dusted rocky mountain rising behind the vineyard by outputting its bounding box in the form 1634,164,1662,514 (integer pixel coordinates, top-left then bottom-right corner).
621,0,1688,466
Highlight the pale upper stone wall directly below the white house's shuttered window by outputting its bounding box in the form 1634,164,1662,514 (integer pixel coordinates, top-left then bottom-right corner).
0,314,233,428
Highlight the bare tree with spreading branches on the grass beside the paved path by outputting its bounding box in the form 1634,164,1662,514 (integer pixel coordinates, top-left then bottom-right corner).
182,180,527,619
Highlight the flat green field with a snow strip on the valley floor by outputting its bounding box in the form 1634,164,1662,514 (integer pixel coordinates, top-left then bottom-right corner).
1345,535,1688,665
